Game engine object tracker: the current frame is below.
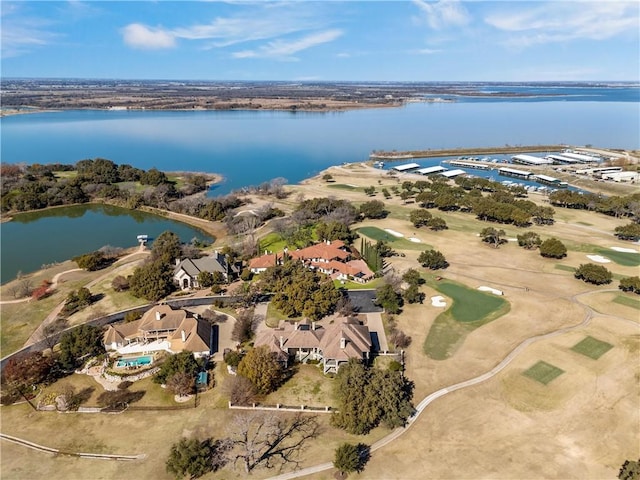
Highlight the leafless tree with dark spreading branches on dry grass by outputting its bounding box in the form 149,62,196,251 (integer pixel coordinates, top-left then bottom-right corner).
229,413,319,473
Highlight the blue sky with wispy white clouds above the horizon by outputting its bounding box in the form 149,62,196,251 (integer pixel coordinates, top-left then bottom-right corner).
0,0,640,81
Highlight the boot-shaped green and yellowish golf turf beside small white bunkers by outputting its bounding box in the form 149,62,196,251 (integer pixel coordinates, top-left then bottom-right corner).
423,280,510,360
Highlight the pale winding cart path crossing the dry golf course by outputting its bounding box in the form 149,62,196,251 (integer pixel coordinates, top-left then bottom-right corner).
269,289,640,480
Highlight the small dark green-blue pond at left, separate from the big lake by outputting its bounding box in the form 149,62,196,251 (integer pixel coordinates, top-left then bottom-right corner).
0,205,211,282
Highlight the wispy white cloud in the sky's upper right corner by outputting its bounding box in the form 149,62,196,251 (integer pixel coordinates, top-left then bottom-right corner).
484,2,640,47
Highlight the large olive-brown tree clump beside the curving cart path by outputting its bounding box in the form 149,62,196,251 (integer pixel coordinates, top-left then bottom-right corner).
331,359,414,435
